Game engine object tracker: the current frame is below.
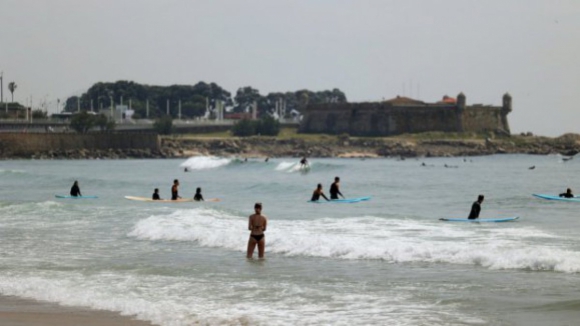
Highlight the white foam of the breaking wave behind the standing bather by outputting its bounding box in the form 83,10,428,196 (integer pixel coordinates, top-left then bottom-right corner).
129,209,580,273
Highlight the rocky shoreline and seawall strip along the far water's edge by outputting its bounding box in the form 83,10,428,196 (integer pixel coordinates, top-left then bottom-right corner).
0,133,580,159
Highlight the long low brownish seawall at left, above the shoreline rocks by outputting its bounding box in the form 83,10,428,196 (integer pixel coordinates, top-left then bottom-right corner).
0,133,160,155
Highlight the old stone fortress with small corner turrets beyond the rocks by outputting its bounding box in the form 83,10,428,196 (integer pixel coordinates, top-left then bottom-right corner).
299,93,512,136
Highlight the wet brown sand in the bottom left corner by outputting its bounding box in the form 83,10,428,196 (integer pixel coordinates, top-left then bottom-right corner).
0,296,153,326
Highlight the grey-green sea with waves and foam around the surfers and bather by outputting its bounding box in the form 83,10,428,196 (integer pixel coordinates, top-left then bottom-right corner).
0,155,580,326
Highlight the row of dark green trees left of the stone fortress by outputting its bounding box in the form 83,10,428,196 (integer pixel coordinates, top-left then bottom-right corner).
64,81,347,118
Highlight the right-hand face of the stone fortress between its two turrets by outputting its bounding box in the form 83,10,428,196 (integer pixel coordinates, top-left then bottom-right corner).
461,106,510,133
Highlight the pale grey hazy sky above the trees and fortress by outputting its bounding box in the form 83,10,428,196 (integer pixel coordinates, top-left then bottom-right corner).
0,0,580,136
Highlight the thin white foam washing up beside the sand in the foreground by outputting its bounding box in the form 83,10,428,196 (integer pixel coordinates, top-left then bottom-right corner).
0,271,474,326
